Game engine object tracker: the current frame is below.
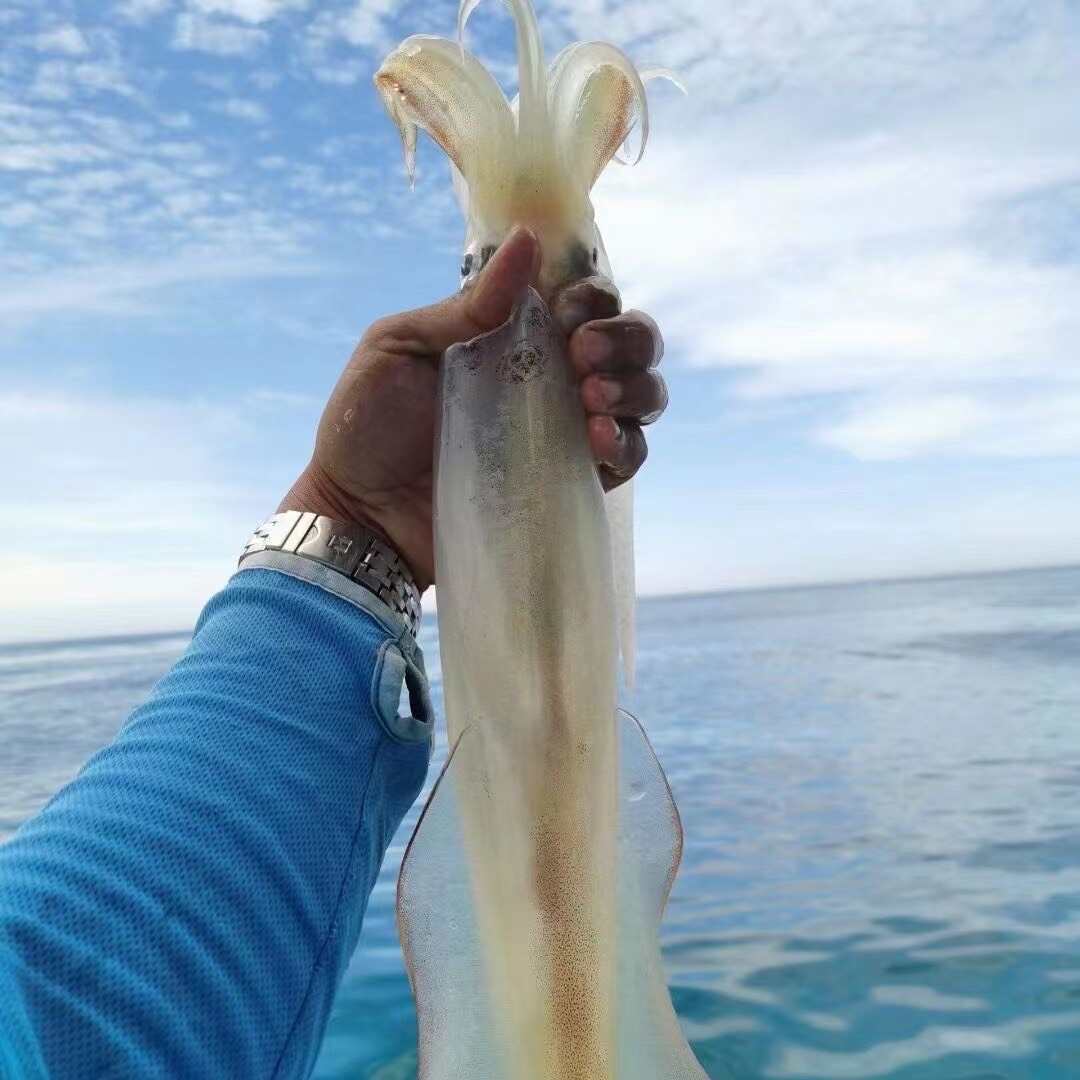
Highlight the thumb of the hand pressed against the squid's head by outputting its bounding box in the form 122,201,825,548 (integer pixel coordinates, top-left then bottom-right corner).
402,226,540,352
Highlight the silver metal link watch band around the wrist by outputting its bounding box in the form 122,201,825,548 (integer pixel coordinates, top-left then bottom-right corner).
240,510,420,637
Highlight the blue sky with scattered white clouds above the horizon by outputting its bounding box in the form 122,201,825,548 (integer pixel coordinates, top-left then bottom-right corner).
0,0,1080,640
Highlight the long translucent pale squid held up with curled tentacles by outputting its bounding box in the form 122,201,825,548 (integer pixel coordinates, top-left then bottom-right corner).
375,0,705,1080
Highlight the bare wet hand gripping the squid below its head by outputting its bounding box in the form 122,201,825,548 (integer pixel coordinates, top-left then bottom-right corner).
279,229,667,591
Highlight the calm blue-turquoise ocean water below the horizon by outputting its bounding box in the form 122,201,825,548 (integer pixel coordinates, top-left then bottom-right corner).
0,569,1080,1080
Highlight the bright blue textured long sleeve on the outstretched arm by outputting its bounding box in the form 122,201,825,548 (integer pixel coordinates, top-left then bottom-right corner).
0,569,431,1080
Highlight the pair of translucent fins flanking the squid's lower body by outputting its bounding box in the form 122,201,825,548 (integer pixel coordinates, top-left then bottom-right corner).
397,713,706,1080
